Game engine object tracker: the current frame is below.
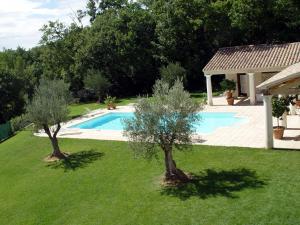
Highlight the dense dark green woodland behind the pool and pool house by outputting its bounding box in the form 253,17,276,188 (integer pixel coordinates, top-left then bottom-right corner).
0,0,300,121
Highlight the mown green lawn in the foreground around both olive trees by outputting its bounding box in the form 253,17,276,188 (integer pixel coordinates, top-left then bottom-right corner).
0,131,300,225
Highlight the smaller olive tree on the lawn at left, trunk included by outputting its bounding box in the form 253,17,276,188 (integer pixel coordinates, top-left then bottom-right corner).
27,79,71,159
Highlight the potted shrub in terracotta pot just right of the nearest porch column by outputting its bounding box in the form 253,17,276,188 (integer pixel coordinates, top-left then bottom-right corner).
272,97,289,139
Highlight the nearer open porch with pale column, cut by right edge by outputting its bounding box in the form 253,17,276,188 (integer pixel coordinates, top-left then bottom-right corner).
257,62,300,149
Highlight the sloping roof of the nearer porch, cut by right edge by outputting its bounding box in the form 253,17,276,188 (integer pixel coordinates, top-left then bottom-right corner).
257,62,300,89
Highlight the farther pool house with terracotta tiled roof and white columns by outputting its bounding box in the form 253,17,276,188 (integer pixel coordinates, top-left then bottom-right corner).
203,42,300,105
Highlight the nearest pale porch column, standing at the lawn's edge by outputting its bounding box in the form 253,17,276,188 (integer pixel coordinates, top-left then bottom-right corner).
263,95,274,149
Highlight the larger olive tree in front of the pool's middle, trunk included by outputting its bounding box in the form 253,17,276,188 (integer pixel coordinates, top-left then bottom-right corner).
124,80,201,181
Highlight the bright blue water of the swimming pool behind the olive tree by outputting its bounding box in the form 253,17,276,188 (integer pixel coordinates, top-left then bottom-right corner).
70,112,246,134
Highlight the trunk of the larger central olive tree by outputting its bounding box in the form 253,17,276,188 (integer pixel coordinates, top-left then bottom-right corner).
164,148,189,182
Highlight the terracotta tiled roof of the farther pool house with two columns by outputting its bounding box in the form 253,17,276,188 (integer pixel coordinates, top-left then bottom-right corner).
203,42,300,75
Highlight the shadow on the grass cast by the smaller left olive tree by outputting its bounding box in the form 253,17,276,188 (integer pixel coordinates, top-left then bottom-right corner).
47,149,104,171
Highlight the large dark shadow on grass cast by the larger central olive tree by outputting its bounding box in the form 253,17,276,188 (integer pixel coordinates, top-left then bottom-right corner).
161,168,266,200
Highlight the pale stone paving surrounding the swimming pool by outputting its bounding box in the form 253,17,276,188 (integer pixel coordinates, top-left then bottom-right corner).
35,97,300,149
